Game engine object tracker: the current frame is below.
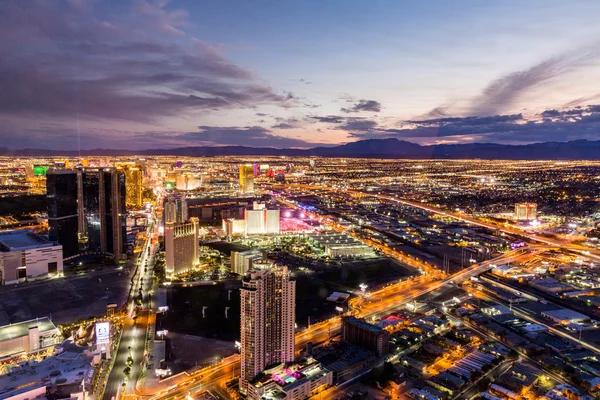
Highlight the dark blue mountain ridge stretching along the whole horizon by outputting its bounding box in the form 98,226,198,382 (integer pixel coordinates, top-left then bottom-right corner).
0,138,600,160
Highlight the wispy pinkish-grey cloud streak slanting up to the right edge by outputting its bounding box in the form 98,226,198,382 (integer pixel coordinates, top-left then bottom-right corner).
469,43,600,115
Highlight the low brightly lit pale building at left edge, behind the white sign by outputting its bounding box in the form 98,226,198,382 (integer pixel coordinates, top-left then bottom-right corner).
0,317,62,359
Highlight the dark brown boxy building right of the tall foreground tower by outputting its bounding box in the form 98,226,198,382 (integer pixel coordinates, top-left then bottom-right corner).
342,317,390,356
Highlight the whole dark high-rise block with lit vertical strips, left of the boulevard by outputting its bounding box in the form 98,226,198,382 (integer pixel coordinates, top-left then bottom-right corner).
46,168,127,260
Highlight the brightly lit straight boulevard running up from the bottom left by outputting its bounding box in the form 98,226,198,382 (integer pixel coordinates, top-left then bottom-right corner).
103,216,155,400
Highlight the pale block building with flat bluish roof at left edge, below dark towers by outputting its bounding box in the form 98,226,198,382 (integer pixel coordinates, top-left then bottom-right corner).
0,230,63,285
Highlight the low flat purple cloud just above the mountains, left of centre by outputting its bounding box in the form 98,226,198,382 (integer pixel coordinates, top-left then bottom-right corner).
177,126,318,147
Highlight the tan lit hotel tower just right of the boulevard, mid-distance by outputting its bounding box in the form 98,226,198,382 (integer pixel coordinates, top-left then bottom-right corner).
165,218,199,276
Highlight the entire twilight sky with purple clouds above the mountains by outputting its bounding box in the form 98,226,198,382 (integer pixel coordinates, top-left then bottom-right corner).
0,0,600,150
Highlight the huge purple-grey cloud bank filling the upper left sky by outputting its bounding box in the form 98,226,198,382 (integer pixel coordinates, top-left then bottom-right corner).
0,1,296,122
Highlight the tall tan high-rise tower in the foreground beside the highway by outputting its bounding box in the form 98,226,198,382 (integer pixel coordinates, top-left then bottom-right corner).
240,263,296,392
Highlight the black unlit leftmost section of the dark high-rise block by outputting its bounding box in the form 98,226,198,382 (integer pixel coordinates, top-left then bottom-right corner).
46,169,79,258
